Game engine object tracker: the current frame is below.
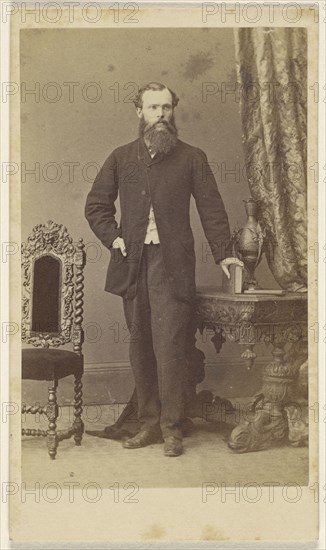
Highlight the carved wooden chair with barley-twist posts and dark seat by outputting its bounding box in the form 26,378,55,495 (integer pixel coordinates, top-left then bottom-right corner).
22,221,85,459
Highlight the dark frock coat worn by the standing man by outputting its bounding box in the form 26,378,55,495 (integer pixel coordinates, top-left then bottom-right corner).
85,138,230,302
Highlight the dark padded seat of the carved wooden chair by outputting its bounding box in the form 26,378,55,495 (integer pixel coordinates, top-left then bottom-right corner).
22,348,83,380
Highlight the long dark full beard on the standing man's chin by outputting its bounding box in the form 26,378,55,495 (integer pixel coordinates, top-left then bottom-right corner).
139,116,178,154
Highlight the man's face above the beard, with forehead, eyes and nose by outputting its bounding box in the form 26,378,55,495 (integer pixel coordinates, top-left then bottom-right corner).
137,89,173,130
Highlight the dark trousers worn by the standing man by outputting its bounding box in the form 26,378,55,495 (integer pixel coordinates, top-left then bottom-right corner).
123,244,192,439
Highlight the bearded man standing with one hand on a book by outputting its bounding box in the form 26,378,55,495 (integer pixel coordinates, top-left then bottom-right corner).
85,82,239,456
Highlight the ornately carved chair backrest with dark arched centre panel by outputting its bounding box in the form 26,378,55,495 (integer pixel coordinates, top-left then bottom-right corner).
22,221,85,354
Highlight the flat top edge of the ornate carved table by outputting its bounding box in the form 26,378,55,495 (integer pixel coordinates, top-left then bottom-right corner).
196,286,308,302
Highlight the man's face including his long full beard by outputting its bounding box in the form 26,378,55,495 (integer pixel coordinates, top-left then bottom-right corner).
137,88,178,153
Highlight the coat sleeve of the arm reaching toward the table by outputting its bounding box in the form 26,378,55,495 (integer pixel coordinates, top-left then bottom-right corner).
192,149,232,263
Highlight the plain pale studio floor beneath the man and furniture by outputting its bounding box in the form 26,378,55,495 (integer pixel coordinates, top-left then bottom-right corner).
22,405,309,488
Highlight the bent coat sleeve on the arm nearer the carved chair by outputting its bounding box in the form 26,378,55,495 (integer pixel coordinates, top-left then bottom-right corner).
85,152,121,248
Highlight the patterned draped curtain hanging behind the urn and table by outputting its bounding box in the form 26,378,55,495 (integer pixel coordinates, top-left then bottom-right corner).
234,27,307,291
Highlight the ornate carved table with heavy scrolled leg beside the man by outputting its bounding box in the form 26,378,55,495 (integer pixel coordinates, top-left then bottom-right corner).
196,287,307,452
